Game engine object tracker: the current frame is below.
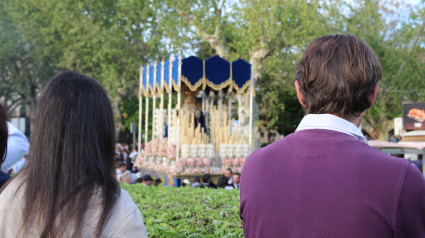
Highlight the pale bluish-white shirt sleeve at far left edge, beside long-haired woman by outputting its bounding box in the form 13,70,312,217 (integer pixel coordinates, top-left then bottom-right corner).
1,122,29,171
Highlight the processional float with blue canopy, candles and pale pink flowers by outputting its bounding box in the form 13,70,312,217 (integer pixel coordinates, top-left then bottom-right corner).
135,56,254,175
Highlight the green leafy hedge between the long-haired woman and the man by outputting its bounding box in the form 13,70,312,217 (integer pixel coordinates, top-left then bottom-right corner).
121,184,243,238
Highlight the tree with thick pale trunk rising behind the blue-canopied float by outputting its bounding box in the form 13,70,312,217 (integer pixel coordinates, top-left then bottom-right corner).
158,0,337,139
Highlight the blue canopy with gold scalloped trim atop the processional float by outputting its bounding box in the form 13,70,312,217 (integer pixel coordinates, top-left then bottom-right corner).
141,55,251,97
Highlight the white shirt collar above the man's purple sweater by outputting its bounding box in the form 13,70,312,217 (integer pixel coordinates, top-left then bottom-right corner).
295,114,367,144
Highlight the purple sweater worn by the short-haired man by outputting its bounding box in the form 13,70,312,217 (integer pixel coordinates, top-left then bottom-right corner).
240,129,425,238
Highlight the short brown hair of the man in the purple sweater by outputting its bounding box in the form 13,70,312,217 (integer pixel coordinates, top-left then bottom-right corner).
295,34,382,116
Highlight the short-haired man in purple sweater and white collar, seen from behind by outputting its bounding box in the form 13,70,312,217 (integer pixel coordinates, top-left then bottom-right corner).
240,34,425,238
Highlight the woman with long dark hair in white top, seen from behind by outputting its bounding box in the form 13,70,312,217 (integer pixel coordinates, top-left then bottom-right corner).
0,72,147,237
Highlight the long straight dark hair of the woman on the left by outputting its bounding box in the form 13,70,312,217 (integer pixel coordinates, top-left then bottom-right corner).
7,72,120,237
